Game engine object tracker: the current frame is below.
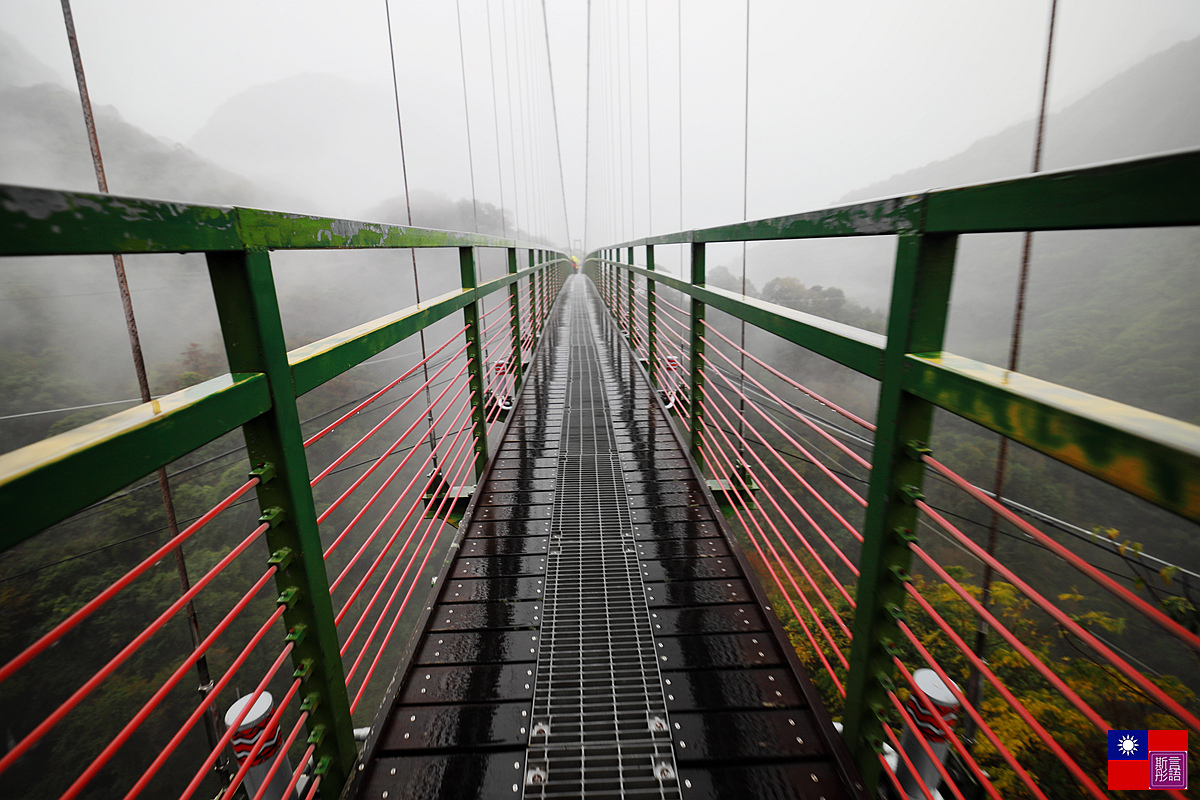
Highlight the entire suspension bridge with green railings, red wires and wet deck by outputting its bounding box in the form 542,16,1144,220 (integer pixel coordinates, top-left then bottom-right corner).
0,1,1200,800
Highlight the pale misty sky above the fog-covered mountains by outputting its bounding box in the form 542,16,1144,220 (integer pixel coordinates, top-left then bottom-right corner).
0,0,1200,246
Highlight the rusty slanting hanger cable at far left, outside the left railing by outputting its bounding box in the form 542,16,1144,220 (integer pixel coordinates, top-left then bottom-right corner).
62,0,232,777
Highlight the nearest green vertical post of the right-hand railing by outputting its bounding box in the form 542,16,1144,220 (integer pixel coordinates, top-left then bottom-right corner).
842,227,958,794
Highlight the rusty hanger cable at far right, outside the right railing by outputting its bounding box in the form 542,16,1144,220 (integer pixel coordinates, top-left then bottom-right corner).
966,0,1058,740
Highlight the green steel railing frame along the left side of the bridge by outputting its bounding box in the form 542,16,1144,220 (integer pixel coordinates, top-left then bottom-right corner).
0,186,572,787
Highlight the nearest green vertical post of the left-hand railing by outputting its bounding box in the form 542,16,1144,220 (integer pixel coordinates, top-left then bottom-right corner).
208,251,358,794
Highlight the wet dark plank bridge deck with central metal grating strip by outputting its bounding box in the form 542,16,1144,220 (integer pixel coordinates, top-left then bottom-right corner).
347,276,865,800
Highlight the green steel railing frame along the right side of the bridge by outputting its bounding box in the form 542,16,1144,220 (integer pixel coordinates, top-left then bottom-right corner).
584,151,1200,787
